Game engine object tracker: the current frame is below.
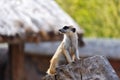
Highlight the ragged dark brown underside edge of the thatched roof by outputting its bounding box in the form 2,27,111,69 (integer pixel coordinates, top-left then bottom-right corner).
0,31,84,46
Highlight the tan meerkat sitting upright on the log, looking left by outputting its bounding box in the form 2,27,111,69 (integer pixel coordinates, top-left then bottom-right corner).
47,26,80,75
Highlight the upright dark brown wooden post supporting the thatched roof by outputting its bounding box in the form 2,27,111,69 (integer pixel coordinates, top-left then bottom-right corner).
9,43,24,80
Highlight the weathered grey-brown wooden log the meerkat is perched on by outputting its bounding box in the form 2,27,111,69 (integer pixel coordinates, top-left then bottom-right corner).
43,56,120,80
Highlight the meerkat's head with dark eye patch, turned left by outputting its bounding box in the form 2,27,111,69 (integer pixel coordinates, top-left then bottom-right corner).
59,26,76,34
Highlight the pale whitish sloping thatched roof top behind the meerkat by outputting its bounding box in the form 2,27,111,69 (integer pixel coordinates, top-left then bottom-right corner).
0,0,83,42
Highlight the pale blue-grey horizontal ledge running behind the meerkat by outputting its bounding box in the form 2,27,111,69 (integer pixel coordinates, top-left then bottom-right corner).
25,38,120,60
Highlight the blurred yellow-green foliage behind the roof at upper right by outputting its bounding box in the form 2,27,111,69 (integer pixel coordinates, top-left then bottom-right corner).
57,0,120,38
